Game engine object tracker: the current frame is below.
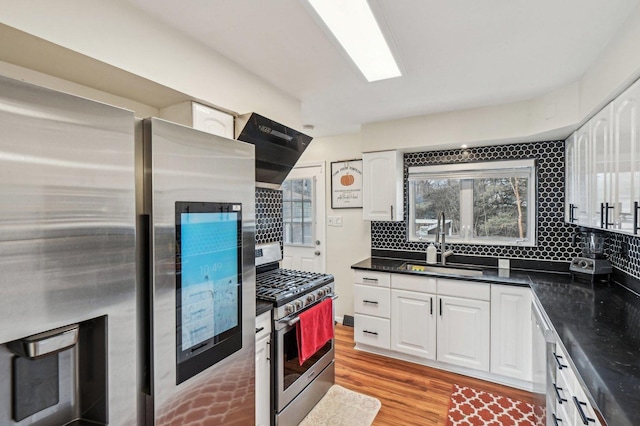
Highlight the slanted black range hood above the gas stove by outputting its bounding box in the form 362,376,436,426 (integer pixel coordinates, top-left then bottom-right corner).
236,112,312,185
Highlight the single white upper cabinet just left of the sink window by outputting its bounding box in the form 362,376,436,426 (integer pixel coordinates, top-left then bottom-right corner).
362,151,404,221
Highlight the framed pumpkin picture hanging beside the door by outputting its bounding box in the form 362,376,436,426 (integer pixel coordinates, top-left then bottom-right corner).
331,160,362,209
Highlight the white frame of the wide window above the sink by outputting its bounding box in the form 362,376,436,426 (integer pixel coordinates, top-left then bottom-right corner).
406,159,538,247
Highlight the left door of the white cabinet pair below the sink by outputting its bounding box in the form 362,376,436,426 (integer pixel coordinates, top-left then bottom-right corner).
391,289,436,360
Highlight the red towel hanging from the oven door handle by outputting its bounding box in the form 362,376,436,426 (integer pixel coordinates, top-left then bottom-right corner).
296,299,333,365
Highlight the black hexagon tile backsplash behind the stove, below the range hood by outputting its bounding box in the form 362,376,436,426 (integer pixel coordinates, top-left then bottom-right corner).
256,188,283,245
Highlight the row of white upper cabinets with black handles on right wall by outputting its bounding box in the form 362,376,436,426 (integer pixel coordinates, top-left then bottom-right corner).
565,81,640,234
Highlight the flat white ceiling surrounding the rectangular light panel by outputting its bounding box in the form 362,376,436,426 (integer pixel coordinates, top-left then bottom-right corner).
126,0,640,137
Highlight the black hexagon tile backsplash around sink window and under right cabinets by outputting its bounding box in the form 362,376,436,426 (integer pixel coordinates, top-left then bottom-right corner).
371,141,640,277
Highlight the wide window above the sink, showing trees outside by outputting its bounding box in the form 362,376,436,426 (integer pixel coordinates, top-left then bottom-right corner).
408,159,537,246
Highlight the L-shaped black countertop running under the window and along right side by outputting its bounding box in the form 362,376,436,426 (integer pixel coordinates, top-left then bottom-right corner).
352,257,640,426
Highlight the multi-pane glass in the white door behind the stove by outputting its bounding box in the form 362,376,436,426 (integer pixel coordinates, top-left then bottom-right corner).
282,178,315,246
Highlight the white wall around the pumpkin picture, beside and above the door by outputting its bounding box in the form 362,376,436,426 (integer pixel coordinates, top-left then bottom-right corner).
300,133,371,318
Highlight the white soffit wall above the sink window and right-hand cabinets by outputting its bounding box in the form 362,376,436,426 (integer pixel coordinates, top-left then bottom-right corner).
362,2,640,152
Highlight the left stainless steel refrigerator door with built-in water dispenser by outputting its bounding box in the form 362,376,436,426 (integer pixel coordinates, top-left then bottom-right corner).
0,78,137,426
